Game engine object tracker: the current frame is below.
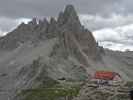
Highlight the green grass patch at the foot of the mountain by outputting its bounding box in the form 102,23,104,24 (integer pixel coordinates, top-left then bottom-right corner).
20,82,80,100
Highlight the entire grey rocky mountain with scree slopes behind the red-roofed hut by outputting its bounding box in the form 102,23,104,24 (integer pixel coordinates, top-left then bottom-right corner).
0,5,133,100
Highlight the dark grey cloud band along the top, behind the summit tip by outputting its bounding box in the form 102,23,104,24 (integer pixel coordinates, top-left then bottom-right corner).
0,0,121,18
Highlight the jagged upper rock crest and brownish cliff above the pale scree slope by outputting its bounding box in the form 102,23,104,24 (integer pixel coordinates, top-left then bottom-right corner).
0,5,99,66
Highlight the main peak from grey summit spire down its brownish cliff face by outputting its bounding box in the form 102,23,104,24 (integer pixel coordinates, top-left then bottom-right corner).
57,5,99,66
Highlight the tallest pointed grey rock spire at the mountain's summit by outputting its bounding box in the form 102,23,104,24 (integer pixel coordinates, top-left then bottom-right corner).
57,5,82,32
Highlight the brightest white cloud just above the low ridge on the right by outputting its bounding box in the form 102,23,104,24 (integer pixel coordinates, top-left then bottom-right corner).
94,24,133,51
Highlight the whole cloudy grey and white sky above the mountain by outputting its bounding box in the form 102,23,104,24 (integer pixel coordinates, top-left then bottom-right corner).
0,0,133,51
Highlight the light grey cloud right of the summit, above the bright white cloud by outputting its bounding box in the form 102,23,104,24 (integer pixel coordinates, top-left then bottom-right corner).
79,14,133,31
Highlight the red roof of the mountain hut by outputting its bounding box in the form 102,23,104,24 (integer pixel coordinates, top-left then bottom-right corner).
95,71,120,80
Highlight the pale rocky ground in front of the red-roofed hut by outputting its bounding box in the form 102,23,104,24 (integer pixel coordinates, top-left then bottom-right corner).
73,81,132,100
